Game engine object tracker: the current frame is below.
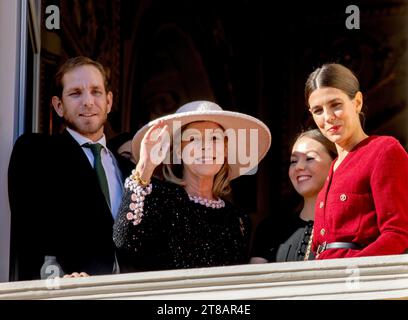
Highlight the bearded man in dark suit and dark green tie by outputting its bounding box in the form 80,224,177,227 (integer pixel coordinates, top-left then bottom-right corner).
9,57,123,280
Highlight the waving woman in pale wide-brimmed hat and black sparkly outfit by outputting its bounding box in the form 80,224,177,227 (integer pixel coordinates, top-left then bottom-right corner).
113,101,271,271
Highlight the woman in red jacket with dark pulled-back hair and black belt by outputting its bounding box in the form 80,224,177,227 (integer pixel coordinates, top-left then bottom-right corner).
305,64,408,259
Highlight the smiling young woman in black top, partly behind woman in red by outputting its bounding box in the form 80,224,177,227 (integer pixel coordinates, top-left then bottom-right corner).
250,129,336,263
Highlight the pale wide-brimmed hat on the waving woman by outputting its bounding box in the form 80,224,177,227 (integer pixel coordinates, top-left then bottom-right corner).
132,101,272,180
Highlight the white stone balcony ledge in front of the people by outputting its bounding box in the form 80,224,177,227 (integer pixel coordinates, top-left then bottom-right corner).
0,255,408,300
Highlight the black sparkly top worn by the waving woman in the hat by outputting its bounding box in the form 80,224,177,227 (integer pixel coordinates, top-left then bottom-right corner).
113,179,251,272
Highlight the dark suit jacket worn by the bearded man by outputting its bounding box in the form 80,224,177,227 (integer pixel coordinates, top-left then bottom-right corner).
9,131,124,280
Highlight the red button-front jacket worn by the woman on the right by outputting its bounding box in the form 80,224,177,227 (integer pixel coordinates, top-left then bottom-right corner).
313,136,408,259
